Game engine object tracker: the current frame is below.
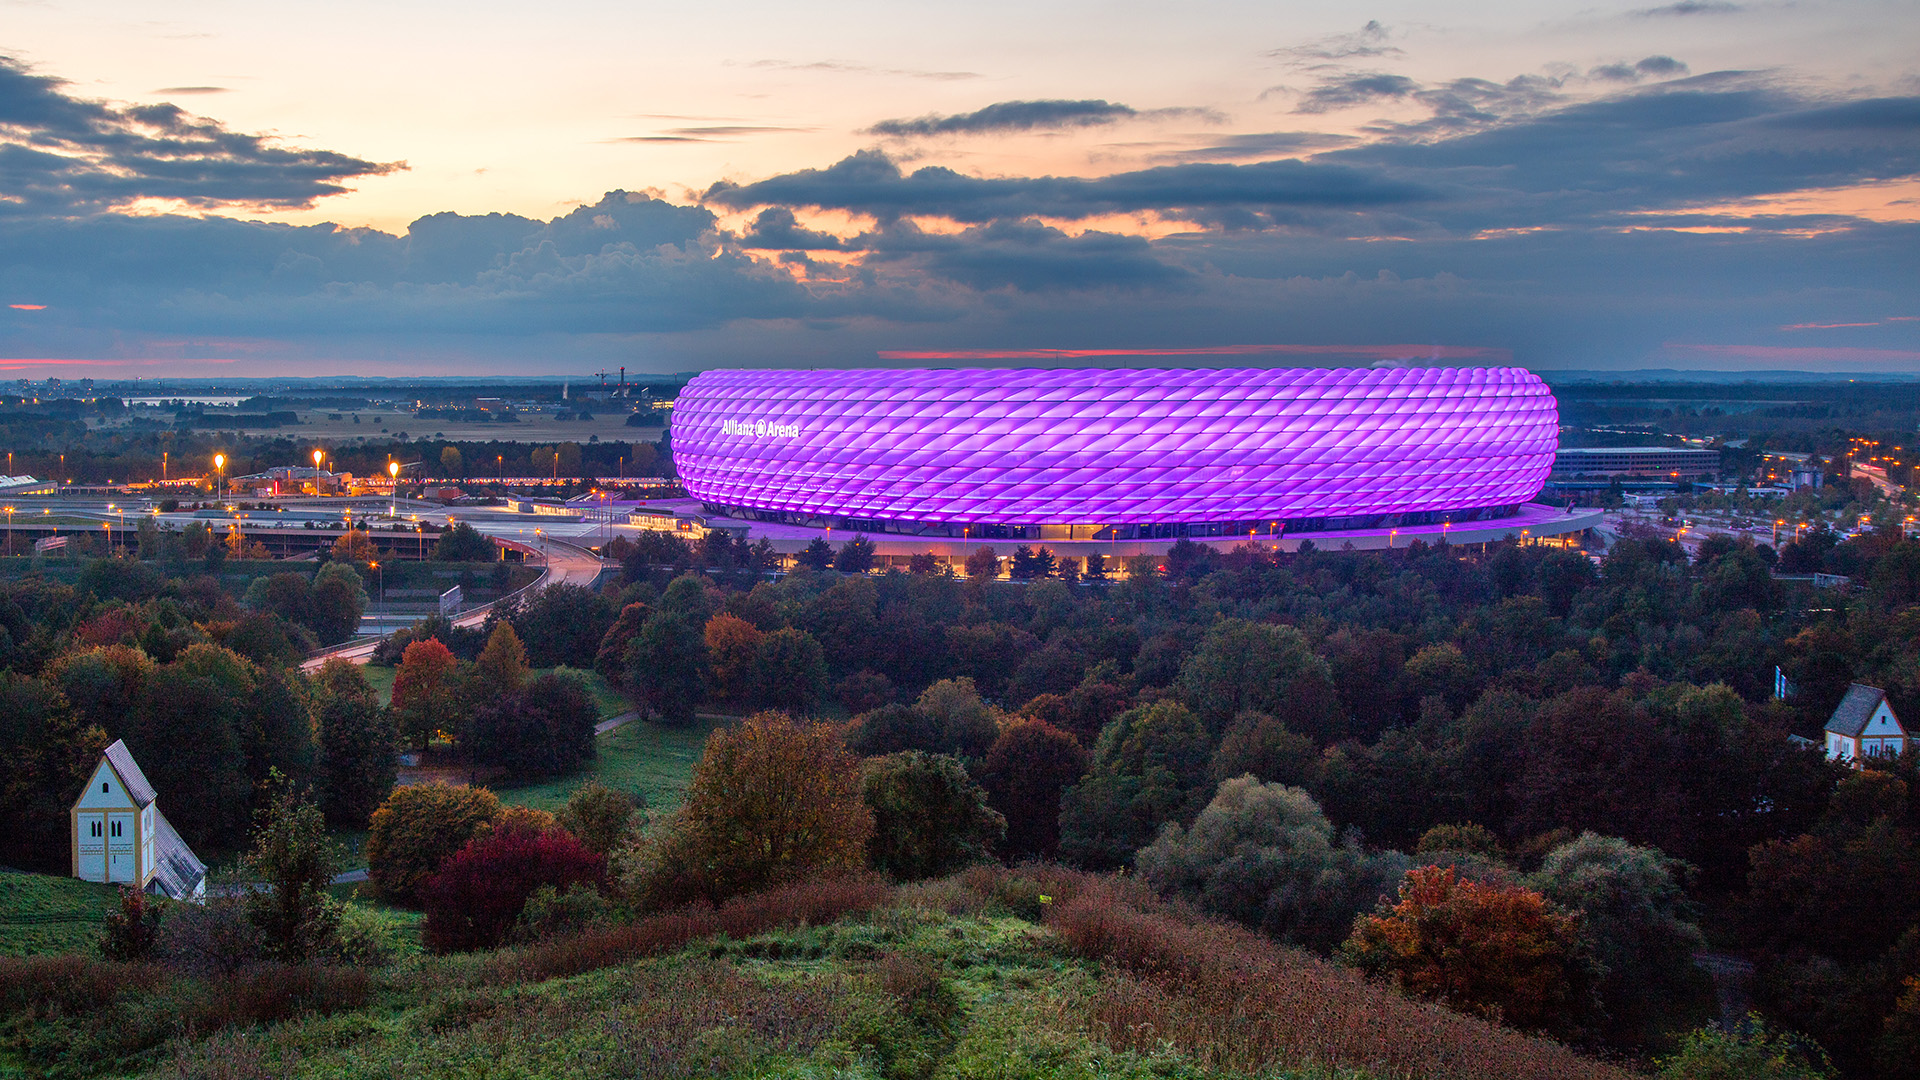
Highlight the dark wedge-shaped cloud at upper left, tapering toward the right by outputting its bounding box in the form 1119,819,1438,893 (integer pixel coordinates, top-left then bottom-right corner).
0,56,405,217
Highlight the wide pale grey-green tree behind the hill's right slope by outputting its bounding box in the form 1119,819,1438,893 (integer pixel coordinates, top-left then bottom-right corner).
1135,776,1407,951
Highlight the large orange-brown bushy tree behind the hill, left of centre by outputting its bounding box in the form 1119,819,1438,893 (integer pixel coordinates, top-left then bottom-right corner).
637,713,874,907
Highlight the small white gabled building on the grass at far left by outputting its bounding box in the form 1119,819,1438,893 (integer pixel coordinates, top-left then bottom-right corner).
69,740,207,901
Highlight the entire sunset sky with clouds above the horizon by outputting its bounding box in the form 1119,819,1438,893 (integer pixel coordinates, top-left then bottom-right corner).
0,0,1920,379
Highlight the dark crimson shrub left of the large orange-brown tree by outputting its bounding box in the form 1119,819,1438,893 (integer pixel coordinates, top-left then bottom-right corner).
420,826,607,953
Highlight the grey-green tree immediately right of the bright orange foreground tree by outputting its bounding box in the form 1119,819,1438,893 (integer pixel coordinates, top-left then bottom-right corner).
1526,832,1713,1045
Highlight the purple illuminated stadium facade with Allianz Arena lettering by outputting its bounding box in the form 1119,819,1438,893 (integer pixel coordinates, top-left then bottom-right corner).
672,367,1559,538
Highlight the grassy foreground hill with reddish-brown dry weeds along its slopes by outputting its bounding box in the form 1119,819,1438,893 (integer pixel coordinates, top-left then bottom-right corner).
0,867,1626,1080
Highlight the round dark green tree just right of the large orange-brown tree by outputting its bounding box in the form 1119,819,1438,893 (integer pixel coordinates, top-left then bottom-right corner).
860,749,1006,882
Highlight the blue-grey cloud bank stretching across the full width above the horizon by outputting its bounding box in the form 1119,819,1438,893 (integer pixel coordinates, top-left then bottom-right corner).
0,56,1920,369
